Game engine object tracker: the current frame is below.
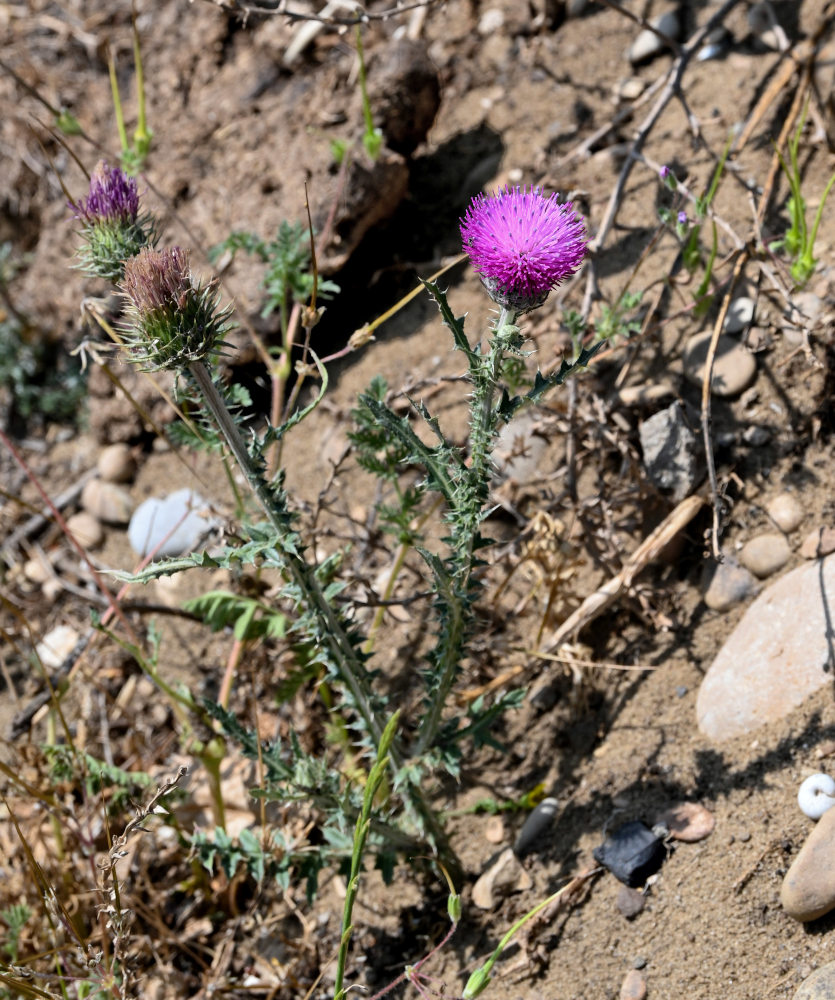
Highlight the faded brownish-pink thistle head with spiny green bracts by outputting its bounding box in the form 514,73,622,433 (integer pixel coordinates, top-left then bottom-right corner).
121,247,229,370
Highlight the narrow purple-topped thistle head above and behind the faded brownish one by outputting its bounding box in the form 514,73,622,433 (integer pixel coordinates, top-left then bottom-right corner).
70,160,157,281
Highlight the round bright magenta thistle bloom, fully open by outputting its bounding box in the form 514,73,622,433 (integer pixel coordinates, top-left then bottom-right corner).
461,187,586,313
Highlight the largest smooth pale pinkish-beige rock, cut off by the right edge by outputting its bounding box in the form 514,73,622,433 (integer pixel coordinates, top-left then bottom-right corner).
696,556,835,740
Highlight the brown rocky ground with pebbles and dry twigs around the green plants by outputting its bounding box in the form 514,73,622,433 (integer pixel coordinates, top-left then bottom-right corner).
6,0,835,1000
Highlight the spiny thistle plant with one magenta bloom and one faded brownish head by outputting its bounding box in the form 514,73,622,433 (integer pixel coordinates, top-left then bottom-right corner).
68,175,601,926
